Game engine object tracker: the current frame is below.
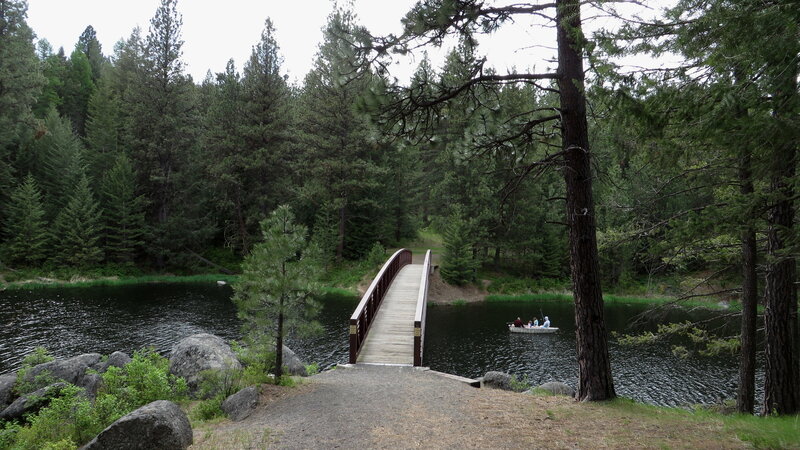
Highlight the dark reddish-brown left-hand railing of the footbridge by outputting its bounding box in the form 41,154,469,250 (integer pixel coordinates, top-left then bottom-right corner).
350,248,411,364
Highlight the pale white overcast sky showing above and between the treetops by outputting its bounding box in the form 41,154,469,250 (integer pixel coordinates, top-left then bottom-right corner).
28,0,668,82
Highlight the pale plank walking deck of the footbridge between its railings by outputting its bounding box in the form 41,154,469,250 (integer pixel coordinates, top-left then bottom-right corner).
358,264,423,365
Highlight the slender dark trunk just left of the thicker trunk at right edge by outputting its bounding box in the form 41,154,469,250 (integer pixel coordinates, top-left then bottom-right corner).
736,154,758,414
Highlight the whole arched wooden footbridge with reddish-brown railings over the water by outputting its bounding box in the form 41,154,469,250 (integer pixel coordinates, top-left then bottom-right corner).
350,249,431,366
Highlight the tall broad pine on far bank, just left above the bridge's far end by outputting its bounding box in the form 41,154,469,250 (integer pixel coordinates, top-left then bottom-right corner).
297,10,387,261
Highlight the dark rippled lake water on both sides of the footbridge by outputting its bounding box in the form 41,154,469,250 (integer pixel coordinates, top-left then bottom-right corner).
0,284,762,406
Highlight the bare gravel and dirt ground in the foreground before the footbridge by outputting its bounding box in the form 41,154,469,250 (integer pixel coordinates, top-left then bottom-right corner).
192,366,745,449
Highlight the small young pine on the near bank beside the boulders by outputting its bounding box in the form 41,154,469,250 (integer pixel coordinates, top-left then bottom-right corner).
233,205,321,383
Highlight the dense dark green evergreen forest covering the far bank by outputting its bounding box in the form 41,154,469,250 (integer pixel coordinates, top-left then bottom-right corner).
0,0,800,413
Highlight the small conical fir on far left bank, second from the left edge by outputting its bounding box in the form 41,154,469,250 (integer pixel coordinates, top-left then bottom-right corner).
51,175,103,268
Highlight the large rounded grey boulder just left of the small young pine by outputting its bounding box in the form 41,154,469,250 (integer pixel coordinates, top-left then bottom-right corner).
169,333,242,392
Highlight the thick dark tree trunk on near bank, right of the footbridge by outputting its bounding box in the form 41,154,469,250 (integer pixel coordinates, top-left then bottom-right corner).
556,0,616,401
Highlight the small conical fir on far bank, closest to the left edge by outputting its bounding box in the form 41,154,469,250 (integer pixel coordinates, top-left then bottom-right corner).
4,174,48,266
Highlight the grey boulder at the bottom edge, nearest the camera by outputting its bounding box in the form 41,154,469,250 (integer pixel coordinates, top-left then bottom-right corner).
82,400,192,450
